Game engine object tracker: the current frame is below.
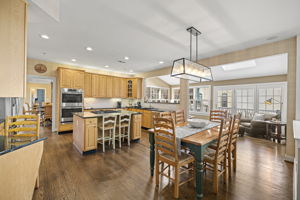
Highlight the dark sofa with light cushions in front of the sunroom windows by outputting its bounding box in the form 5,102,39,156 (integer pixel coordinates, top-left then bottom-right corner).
239,113,279,138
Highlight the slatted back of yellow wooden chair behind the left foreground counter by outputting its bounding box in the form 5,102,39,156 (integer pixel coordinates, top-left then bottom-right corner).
5,115,40,137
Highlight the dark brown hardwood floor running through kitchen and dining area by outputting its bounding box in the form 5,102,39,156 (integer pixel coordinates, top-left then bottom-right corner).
33,128,293,200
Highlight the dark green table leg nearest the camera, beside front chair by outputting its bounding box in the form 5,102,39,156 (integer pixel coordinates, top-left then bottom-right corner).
189,146,204,199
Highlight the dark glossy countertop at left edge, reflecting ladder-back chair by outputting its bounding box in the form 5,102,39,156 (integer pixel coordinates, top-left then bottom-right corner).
0,136,47,156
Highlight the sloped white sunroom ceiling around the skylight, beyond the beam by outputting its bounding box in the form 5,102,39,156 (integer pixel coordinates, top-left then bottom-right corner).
159,54,288,85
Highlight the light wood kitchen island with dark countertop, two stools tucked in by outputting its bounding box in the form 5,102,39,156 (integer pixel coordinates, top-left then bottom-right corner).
73,110,142,154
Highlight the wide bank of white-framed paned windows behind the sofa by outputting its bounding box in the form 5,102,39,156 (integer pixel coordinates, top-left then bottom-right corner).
214,82,287,120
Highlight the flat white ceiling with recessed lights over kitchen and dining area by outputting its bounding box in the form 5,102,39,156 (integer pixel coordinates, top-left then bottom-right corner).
28,0,300,73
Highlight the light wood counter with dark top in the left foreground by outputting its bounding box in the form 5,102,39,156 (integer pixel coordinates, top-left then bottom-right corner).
0,136,47,199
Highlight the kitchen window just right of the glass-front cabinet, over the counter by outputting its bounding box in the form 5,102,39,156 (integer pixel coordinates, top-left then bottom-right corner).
146,87,169,102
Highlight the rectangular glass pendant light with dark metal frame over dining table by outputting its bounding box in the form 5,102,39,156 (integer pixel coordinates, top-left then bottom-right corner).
171,27,213,82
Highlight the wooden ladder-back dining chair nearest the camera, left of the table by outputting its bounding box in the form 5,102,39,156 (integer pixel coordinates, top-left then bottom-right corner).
154,118,195,198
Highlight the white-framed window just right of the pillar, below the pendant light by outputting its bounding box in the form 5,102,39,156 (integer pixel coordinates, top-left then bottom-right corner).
189,86,210,114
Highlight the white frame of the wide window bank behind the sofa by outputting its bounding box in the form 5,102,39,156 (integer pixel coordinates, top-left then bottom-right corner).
213,82,287,121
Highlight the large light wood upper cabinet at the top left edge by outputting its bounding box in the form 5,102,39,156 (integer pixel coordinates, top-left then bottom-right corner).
0,0,27,97
